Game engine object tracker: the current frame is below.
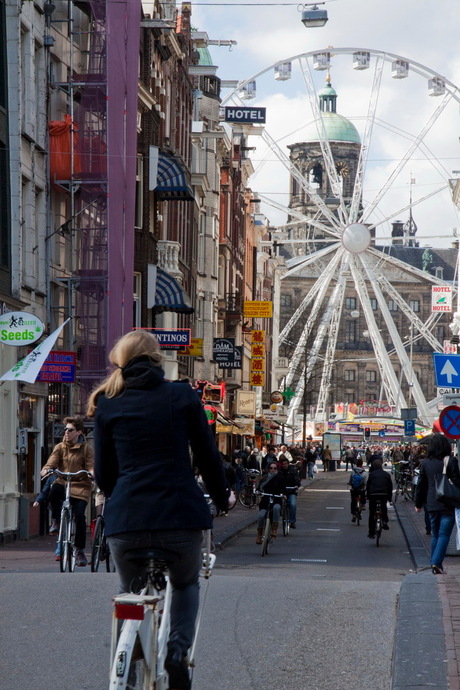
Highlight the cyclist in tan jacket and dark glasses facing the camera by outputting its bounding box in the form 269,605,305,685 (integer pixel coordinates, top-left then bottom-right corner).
40,417,94,566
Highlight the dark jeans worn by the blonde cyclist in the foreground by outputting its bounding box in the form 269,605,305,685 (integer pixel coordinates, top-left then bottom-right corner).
109,529,203,655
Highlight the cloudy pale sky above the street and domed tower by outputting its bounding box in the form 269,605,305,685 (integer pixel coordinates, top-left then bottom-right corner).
181,0,460,247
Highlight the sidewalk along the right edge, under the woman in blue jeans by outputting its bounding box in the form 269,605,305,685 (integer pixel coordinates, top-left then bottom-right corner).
393,490,460,690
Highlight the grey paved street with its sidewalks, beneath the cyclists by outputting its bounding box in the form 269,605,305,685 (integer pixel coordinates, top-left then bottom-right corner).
0,471,460,690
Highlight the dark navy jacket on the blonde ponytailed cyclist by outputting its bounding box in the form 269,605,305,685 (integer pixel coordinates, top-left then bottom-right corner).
94,357,229,535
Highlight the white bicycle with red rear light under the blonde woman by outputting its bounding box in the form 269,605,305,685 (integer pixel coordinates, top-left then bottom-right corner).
109,530,216,690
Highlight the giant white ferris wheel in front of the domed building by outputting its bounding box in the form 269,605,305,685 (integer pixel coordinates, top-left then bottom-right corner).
222,48,460,425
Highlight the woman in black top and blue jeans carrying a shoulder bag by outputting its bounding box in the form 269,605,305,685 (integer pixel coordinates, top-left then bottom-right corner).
415,434,460,575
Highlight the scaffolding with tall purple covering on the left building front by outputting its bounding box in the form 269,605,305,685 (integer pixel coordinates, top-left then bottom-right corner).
51,0,140,413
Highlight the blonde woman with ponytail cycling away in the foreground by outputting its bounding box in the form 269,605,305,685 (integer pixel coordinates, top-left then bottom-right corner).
88,330,230,690
